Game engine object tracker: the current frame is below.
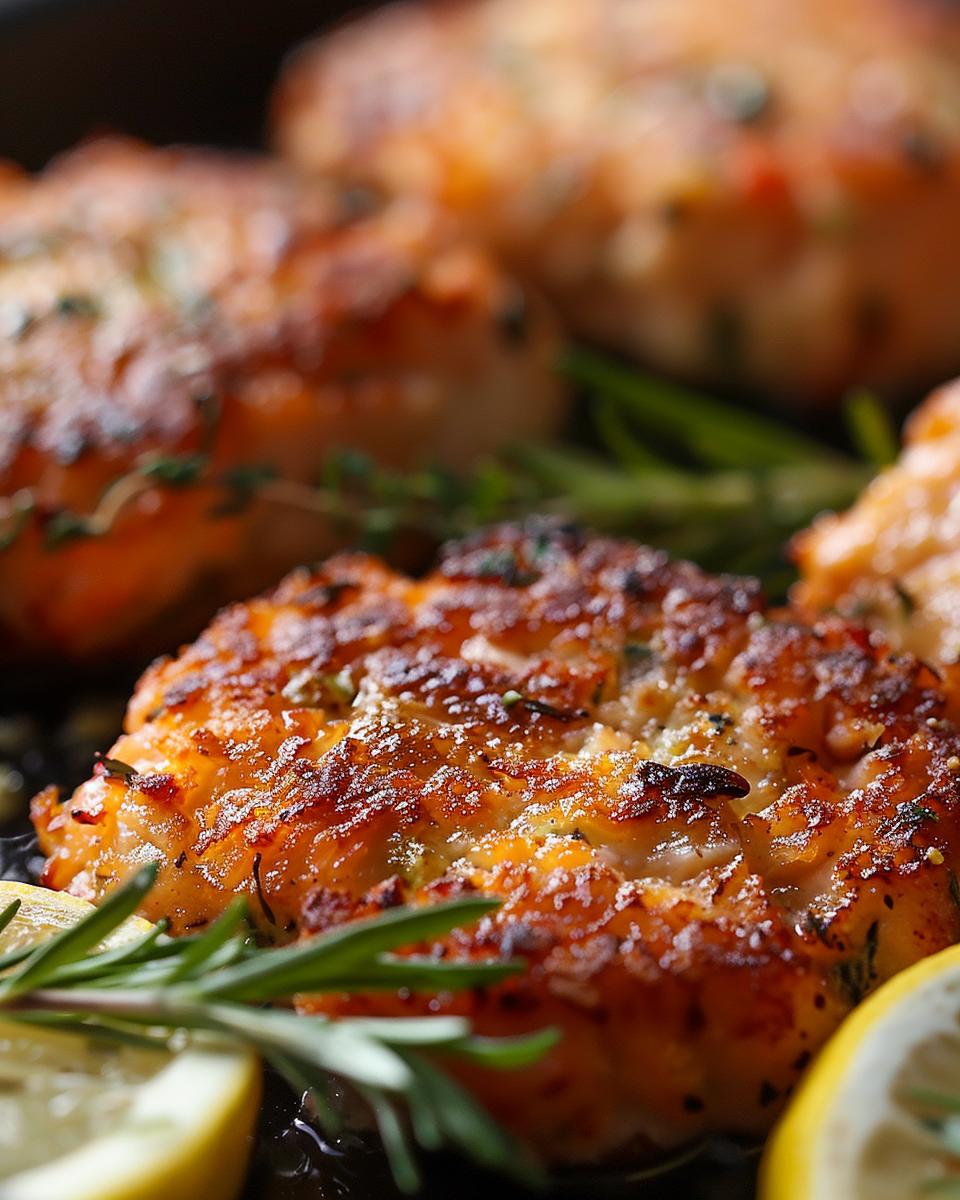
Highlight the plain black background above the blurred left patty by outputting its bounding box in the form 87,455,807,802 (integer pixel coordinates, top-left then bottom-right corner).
0,0,365,168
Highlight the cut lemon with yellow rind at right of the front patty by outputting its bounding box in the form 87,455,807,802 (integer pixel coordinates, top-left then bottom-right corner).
760,947,960,1200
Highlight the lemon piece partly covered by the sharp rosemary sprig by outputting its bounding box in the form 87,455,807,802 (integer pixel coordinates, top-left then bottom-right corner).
0,882,259,1200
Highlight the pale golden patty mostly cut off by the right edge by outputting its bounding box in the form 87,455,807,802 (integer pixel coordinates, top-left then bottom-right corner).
794,383,960,666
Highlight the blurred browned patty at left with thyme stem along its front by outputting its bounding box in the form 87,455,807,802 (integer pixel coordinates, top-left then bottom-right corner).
0,142,563,658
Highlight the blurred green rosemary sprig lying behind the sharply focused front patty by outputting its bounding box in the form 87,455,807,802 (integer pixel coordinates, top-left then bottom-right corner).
552,348,895,595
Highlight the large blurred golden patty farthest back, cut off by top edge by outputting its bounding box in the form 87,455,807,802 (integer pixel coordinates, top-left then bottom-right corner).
274,0,960,406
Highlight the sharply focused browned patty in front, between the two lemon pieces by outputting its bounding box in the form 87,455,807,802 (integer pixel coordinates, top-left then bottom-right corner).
34,522,960,1162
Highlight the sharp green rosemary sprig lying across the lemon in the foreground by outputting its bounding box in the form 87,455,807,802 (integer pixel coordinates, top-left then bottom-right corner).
0,865,556,1192
